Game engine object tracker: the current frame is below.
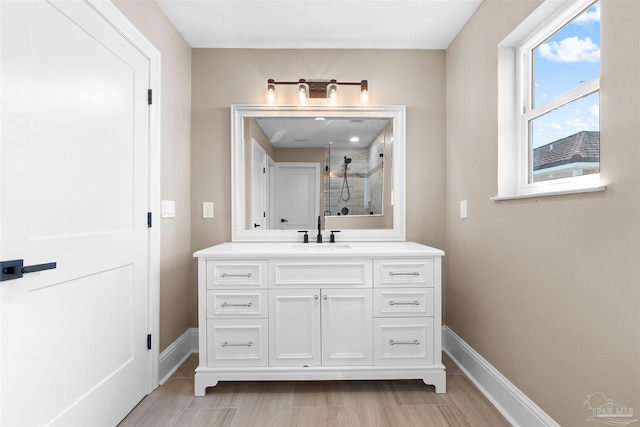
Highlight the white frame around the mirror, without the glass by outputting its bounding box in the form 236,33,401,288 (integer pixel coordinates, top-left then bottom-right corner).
231,105,406,242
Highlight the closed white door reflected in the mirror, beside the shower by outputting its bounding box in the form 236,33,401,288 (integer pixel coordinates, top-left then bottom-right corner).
274,162,320,234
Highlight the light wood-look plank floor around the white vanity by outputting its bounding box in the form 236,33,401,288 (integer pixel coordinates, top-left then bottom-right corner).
120,355,509,427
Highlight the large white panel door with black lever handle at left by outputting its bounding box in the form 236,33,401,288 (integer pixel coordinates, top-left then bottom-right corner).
0,0,149,426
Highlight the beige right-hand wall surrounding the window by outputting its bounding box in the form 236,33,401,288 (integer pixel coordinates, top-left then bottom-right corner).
446,0,640,426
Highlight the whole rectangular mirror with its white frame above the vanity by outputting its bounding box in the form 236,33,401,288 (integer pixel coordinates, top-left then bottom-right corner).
231,105,405,241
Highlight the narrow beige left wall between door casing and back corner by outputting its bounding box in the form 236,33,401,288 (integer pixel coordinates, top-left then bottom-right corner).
113,0,195,351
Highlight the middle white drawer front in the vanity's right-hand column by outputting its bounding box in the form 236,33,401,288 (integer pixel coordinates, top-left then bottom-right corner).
373,288,433,317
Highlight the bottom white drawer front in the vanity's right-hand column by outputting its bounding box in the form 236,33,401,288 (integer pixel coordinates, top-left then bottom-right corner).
373,317,434,365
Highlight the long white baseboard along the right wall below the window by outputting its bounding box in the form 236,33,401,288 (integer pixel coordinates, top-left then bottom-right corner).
442,326,559,427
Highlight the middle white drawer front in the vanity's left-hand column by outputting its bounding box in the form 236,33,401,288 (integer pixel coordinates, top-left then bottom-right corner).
207,290,268,318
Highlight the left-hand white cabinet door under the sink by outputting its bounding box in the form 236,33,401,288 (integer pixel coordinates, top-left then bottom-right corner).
269,289,321,366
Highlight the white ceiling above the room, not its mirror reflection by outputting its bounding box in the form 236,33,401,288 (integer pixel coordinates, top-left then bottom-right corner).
157,0,482,49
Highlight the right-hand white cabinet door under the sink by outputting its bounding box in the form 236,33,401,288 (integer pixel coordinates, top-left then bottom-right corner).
322,289,373,365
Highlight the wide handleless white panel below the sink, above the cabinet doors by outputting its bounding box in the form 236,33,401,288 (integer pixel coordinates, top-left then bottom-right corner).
270,259,372,288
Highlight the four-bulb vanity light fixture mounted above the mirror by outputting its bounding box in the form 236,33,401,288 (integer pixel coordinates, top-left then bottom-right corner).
267,79,369,105
